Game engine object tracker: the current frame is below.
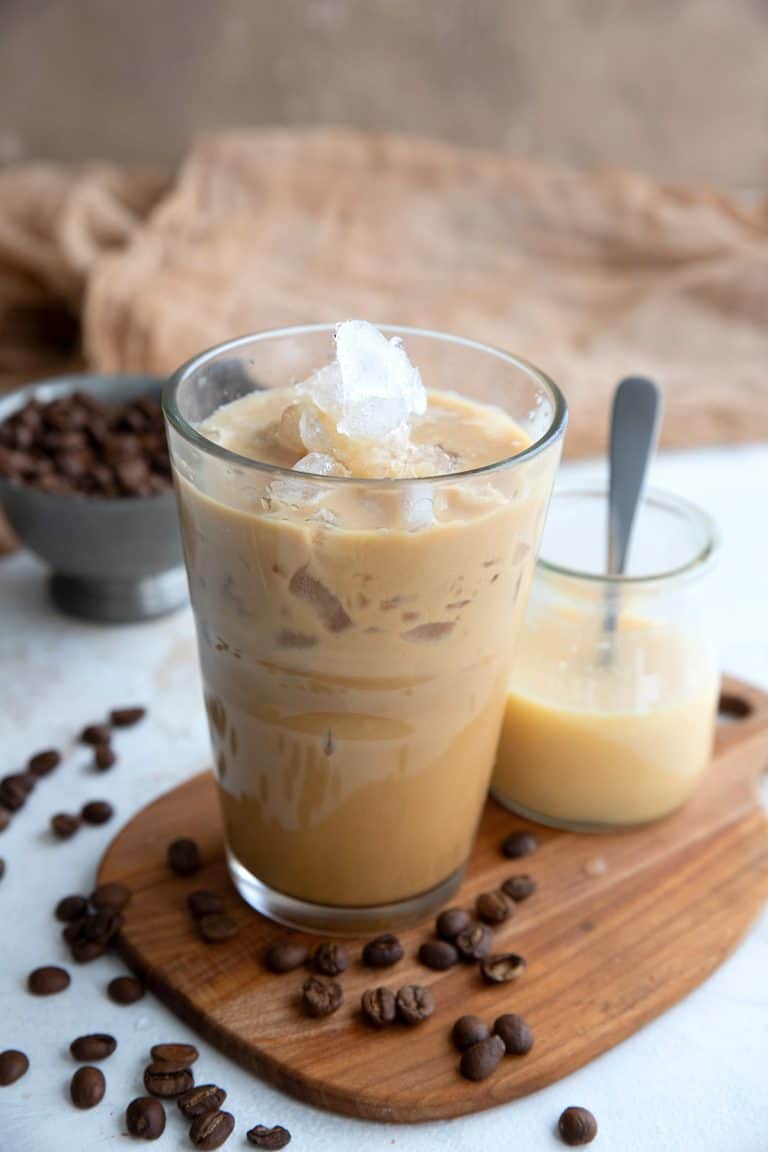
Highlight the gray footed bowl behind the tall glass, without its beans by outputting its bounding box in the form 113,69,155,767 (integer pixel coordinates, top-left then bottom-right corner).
0,373,187,622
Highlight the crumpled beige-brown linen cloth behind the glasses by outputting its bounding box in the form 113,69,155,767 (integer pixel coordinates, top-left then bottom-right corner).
0,123,768,455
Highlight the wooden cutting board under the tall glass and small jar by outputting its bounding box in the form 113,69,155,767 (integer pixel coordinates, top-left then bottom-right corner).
99,681,768,1122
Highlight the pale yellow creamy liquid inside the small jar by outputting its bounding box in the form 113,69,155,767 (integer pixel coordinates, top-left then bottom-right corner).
493,611,718,826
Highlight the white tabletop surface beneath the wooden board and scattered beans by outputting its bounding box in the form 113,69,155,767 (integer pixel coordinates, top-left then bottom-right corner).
0,446,768,1152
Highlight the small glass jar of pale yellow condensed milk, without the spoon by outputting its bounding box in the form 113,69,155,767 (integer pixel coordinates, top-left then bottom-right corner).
492,490,720,832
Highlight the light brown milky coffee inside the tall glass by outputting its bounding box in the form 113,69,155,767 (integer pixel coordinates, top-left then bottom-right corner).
177,389,556,907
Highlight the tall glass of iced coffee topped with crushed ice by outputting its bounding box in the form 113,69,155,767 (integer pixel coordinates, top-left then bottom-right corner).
165,321,567,933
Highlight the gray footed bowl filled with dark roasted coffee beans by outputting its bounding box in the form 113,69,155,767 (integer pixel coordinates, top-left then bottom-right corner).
0,373,187,622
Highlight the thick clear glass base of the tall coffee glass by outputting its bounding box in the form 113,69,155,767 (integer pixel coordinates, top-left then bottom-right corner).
227,848,466,937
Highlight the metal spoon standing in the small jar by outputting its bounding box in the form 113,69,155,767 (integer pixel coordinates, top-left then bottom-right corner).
600,376,661,665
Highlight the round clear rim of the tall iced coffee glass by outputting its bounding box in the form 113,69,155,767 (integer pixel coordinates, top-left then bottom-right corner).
162,321,568,487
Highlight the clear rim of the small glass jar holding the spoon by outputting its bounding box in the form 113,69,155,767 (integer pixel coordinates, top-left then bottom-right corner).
537,484,721,588
